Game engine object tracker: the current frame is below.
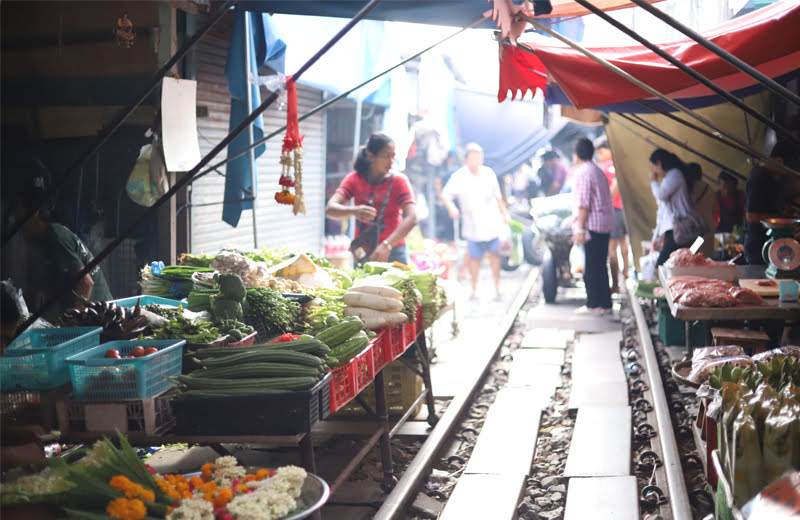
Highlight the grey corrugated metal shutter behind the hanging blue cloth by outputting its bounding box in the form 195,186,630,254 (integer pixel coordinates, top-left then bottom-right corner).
191,19,325,253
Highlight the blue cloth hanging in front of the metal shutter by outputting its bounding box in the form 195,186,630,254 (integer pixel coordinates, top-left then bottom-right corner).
222,7,286,227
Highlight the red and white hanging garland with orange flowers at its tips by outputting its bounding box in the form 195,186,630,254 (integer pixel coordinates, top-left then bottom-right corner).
275,76,306,215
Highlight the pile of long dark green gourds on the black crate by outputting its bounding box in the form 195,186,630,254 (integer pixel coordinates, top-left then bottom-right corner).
173,337,330,397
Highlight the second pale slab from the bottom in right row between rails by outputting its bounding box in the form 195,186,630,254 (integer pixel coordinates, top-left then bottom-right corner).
564,406,631,477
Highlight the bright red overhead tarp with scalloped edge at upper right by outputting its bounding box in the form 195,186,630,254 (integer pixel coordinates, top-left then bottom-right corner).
498,0,800,108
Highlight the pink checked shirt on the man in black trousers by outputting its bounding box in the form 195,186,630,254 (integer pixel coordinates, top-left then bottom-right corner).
572,161,614,233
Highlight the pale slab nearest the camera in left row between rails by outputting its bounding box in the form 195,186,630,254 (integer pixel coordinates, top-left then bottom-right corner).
439,474,525,520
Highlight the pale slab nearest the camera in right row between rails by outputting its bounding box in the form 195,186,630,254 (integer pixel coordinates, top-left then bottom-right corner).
564,477,639,520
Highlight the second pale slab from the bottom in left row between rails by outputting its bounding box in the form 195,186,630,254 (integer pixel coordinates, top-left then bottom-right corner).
464,387,550,477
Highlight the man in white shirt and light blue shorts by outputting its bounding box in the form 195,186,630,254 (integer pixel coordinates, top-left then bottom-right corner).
442,143,508,300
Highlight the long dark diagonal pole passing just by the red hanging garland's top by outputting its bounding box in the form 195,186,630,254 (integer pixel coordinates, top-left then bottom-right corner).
17,0,381,333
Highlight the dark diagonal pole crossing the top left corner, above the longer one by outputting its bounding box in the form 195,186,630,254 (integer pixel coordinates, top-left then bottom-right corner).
0,0,236,245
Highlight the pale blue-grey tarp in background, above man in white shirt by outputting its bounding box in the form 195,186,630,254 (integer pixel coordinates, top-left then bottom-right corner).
453,88,567,174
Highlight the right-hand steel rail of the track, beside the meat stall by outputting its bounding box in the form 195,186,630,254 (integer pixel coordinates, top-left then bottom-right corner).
626,283,693,520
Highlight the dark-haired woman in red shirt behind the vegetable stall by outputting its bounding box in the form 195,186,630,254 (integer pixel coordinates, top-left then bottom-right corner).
325,133,417,264
